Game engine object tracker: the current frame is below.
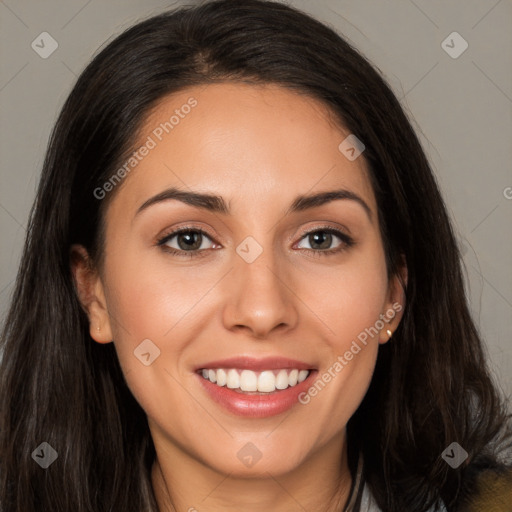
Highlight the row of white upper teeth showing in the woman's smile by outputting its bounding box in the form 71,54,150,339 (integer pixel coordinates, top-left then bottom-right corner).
201,368,309,393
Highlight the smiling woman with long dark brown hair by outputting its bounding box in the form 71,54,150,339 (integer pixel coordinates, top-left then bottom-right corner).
0,0,510,512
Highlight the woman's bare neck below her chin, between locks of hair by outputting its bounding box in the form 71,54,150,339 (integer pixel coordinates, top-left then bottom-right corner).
152,433,352,512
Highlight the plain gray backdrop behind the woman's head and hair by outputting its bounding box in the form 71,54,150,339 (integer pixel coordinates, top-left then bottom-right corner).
0,0,512,393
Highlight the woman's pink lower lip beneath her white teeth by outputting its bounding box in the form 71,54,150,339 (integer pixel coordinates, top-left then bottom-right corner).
196,370,317,418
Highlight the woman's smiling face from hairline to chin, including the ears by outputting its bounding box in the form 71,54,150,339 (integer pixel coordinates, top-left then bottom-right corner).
75,83,403,475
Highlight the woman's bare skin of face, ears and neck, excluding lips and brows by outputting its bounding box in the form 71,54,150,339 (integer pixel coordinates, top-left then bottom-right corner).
72,83,406,512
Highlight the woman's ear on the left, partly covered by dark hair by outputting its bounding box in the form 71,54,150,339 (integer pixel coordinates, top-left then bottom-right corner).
70,244,112,343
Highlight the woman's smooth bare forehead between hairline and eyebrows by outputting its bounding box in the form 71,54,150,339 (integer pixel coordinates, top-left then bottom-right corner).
107,82,375,220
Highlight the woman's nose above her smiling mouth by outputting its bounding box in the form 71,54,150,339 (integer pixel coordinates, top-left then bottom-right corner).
223,245,298,339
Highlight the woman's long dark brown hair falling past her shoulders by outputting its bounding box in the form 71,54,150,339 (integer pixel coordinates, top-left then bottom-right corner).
0,0,510,512
